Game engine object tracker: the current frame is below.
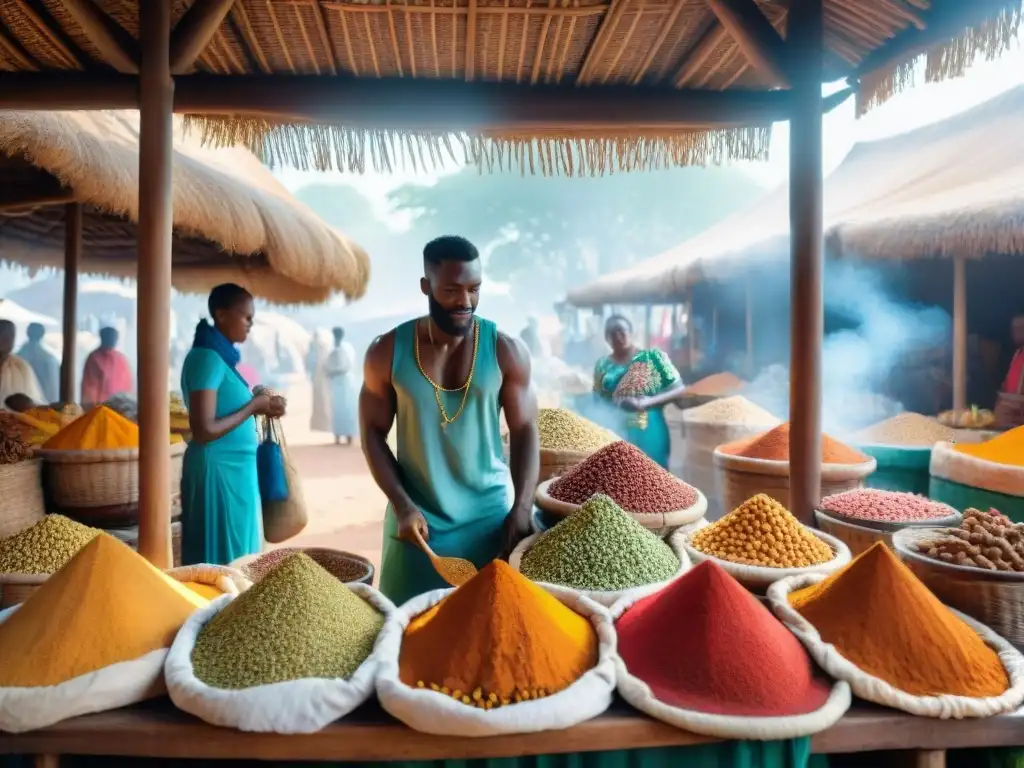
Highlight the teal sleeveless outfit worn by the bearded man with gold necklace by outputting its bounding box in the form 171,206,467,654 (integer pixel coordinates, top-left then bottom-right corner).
380,318,511,604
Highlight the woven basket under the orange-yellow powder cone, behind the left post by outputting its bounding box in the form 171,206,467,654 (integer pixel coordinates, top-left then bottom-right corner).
39,442,185,510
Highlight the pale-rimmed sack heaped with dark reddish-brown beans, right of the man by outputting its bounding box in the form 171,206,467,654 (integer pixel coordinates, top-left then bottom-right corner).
536,440,708,534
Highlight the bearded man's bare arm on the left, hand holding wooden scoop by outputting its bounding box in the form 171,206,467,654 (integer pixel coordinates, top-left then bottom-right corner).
359,331,428,539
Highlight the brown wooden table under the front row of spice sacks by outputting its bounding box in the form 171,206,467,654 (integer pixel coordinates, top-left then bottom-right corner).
0,699,1024,768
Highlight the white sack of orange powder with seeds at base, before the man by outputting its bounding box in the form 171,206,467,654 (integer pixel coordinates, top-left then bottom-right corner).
377,560,615,736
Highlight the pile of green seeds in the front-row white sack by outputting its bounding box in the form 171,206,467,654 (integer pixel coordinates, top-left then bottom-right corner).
191,553,384,689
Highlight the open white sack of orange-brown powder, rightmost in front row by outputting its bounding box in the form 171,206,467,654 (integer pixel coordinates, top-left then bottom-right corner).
768,542,1024,719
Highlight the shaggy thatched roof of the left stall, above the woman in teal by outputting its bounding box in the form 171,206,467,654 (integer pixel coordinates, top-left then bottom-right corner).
0,112,370,303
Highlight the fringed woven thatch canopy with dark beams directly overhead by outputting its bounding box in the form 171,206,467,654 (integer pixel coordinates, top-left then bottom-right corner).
0,0,1020,174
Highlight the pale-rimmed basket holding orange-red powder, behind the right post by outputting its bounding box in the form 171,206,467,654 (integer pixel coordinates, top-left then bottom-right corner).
715,451,878,518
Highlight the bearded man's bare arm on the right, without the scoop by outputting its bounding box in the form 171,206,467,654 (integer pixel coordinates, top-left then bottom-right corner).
498,334,541,555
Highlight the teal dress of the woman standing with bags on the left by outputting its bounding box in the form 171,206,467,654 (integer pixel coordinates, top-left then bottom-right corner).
181,347,263,565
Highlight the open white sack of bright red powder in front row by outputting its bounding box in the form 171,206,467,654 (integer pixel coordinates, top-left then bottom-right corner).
611,562,851,740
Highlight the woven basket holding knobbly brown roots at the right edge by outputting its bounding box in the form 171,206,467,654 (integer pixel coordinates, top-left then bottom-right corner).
893,528,1024,648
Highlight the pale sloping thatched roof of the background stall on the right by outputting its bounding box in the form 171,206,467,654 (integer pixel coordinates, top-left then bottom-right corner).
568,86,1024,306
